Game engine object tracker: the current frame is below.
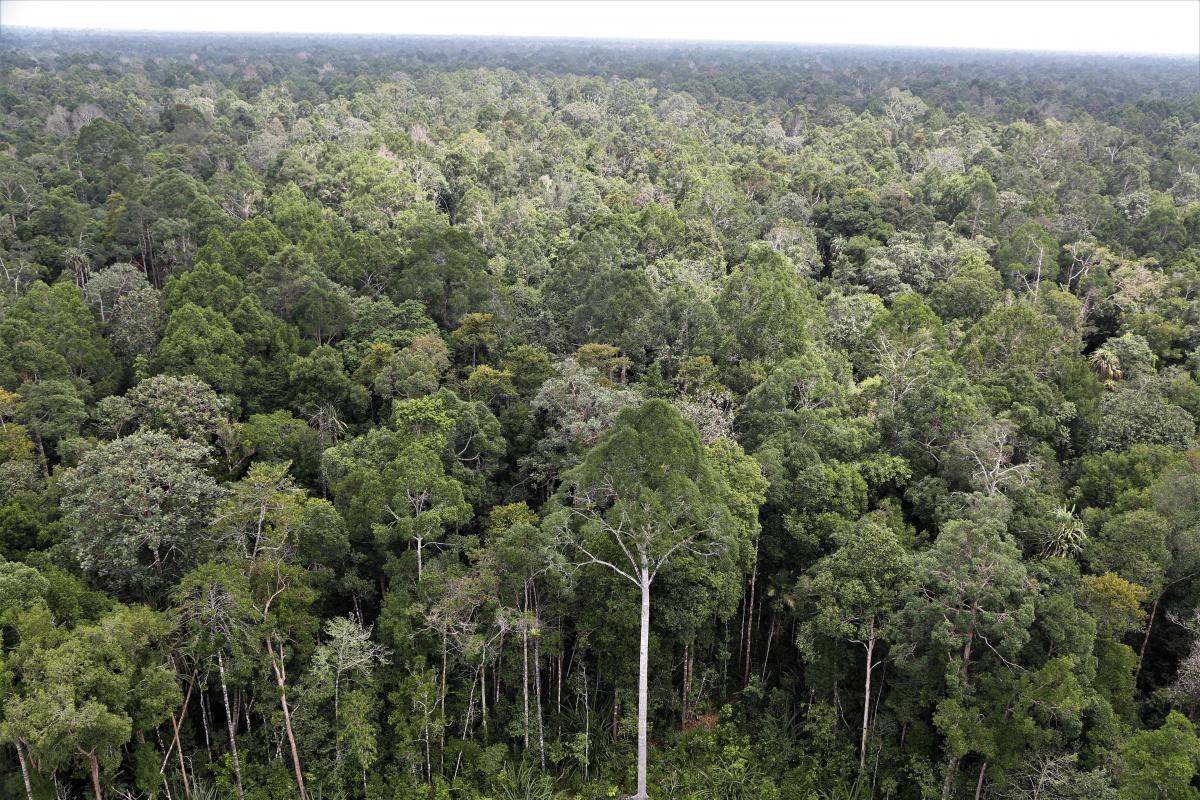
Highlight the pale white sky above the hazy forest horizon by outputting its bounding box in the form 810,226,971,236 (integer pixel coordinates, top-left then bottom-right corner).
0,0,1200,57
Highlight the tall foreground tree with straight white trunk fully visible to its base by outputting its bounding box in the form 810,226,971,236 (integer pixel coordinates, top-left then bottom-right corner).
547,399,734,800
